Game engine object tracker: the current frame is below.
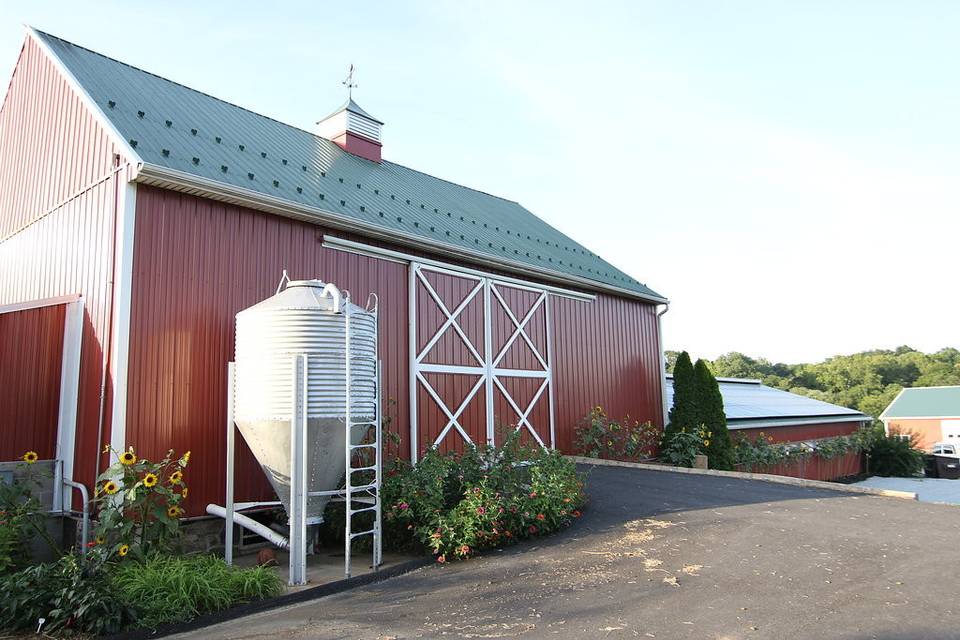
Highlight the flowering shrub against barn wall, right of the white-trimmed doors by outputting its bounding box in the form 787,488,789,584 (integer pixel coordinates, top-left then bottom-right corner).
574,406,662,460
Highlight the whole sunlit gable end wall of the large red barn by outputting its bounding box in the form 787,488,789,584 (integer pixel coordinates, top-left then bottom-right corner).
0,39,124,484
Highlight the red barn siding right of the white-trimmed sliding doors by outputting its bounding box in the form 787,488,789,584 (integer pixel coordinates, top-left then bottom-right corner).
550,294,663,451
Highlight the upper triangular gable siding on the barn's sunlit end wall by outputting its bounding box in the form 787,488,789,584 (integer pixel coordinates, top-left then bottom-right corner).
0,37,117,240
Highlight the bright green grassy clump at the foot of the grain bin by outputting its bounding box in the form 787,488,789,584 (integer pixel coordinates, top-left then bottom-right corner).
111,555,284,627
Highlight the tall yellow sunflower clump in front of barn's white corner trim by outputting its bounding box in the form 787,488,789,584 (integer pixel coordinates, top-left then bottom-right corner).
89,447,190,559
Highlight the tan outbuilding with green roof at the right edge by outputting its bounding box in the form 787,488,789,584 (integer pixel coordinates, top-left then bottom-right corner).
880,386,960,451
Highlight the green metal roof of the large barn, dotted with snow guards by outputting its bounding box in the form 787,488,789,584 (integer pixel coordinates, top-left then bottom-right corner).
36,32,663,300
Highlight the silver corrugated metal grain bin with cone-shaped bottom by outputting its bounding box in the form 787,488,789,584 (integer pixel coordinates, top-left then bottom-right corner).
235,280,377,524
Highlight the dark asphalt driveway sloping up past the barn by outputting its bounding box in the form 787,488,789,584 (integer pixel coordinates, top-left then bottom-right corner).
174,467,960,640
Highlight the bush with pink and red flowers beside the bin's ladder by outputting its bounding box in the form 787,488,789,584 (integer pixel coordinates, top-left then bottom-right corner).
383,433,585,563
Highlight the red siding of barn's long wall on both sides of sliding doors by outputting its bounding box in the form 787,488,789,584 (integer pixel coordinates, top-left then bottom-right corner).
127,186,660,514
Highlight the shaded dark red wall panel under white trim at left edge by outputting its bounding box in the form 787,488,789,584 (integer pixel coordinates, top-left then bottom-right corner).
0,304,66,460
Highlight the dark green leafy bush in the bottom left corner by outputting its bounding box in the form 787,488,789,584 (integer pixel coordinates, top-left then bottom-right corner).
0,555,135,635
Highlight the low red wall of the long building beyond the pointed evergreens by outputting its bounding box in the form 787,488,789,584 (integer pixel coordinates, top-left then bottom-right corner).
730,422,864,480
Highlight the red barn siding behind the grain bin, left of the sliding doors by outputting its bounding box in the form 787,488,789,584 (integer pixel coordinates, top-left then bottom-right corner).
127,187,409,515
